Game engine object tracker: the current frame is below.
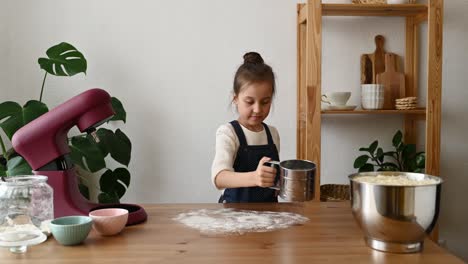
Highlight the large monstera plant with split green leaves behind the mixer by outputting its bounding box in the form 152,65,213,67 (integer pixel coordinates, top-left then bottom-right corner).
0,42,132,203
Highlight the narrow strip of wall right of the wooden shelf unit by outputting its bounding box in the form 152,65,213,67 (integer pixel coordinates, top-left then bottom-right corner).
440,0,468,261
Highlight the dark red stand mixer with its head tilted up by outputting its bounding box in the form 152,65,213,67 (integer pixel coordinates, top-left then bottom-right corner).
12,89,147,225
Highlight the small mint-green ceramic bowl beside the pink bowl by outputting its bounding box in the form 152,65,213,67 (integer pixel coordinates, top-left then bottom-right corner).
50,215,93,246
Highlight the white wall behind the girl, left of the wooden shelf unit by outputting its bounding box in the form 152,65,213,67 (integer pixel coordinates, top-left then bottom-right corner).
0,0,296,203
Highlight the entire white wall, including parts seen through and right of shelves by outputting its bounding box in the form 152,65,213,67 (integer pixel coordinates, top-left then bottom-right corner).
0,0,468,259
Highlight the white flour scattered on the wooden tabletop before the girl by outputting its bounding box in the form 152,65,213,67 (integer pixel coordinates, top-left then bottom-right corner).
174,208,309,234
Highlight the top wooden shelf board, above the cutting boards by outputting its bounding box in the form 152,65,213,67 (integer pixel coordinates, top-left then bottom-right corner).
298,4,428,24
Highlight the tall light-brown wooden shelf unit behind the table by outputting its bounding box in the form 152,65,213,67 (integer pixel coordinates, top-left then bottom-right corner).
297,0,443,201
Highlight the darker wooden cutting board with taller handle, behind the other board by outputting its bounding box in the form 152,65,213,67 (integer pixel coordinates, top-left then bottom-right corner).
361,35,400,84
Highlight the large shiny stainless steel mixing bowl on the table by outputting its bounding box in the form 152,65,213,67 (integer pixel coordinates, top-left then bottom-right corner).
349,171,443,253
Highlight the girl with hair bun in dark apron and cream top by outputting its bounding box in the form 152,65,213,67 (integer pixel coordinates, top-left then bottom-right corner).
211,52,280,203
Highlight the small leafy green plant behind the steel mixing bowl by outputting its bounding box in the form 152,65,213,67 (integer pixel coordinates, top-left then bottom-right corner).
354,130,426,172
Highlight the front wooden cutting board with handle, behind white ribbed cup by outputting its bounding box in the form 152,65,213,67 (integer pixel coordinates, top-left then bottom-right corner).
377,53,405,109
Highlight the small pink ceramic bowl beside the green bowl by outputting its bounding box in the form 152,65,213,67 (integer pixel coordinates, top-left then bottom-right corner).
89,208,128,236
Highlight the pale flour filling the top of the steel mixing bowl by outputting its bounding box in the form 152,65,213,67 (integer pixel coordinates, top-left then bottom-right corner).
354,175,439,186
